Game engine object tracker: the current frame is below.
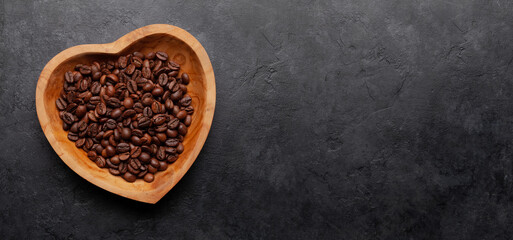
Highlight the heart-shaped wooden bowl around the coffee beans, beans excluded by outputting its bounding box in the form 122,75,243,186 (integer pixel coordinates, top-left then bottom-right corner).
36,24,216,203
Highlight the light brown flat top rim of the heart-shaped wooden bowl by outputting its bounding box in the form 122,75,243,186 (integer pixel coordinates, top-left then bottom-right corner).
36,24,216,204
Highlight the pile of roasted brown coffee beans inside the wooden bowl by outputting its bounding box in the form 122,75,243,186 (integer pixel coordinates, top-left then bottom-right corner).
55,52,194,182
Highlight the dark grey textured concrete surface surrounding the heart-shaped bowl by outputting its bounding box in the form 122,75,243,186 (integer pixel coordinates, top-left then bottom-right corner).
0,0,513,239
